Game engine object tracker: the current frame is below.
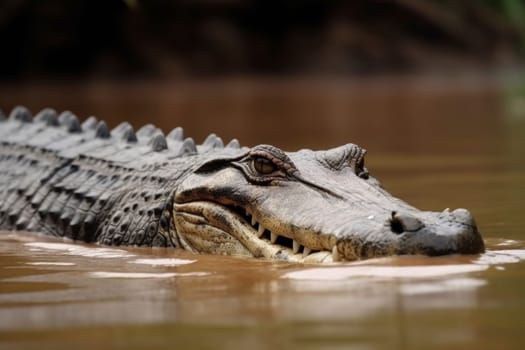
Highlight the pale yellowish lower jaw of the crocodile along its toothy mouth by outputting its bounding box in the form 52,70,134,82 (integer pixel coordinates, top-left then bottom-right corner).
174,201,341,263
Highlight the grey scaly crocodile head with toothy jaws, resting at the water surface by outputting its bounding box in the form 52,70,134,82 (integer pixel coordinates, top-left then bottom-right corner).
173,144,484,262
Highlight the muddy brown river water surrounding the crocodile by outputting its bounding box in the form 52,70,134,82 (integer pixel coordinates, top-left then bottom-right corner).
0,77,525,349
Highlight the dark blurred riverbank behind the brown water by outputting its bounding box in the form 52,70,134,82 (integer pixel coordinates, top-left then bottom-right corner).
0,0,523,79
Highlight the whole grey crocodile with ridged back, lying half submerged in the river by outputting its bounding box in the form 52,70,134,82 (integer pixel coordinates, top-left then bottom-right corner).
0,106,484,263
